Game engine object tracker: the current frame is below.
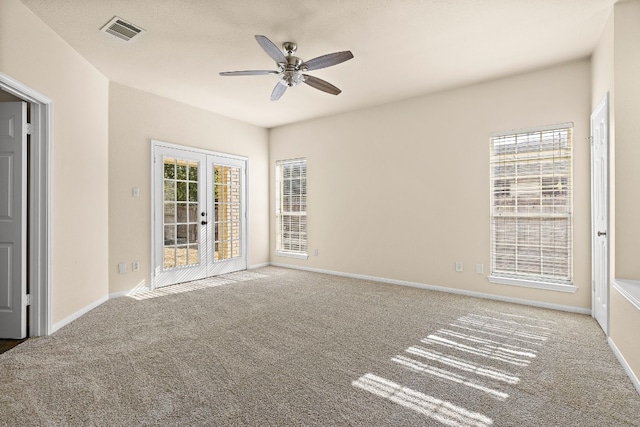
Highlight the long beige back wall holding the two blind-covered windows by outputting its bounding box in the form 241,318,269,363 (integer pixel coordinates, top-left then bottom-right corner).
270,60,591,308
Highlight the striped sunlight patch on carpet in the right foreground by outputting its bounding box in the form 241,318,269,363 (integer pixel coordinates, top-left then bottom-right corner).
351,312,553,427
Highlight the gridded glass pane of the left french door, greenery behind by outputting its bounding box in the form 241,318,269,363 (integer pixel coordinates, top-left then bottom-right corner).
163,157,200,270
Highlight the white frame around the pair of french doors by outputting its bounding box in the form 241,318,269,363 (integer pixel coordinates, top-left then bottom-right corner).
149,139,249,290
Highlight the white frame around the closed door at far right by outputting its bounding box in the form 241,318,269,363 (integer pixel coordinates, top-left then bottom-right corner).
589,92,611,336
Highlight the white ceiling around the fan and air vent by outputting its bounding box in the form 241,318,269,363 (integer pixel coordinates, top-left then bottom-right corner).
22,0,616,128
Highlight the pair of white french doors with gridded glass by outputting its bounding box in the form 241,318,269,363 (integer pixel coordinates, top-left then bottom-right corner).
152,141,247,288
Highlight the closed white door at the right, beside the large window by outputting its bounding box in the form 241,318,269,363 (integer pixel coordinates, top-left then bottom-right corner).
591,95,609,335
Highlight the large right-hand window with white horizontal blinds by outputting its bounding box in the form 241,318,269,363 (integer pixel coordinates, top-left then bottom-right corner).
490,124,575,292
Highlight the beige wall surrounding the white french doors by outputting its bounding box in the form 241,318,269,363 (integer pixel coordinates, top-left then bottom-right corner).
109,83,269,293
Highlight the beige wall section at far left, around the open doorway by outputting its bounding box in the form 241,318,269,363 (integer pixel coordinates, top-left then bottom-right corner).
0,0,108,324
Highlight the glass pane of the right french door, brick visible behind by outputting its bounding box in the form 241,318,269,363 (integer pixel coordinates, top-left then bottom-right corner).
213,165,241,261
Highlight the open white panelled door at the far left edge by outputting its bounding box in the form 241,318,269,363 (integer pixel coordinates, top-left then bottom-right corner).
0,102,27,338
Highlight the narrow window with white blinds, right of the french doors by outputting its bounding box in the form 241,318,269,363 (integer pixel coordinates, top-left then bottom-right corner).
276,159,307,259
